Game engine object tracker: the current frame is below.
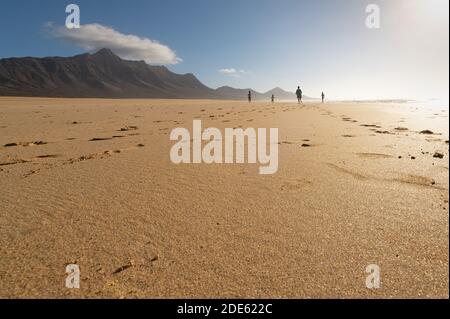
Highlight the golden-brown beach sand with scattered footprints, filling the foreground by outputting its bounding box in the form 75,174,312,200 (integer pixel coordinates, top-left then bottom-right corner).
0,98,449,298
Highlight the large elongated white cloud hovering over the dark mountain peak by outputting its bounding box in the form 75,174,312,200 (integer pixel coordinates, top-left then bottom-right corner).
47,23,182,64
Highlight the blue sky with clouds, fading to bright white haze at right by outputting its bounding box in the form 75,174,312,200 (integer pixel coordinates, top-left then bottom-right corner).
0,0,449,100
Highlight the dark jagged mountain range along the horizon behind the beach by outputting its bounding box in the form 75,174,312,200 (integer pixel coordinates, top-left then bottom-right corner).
0,49,310,100
